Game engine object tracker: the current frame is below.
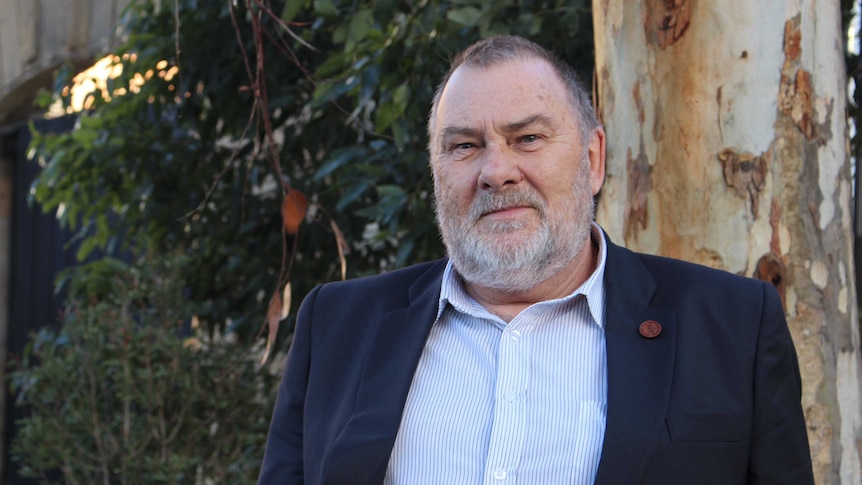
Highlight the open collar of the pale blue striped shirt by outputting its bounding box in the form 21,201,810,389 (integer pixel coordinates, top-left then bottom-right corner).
437,222,608,328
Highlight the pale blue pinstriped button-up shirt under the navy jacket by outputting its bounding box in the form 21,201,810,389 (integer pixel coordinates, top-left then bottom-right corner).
384,224,607,485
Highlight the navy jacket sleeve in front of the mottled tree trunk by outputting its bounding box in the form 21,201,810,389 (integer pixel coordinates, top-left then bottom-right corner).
748,284,814,485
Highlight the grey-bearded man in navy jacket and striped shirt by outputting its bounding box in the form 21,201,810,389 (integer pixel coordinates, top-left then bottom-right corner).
259,37,813,485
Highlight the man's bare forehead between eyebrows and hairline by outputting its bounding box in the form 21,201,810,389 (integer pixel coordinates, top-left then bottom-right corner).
434,58,571,129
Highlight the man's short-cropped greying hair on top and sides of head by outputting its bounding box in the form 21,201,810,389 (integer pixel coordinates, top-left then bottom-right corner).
428,35,601,157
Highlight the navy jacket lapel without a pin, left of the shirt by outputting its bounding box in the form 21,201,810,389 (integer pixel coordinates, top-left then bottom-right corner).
323,260,446,485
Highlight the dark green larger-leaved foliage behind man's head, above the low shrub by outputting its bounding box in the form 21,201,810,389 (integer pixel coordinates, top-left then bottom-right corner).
25,0,592,341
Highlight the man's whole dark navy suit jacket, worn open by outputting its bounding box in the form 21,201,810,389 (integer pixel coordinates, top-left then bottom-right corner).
259,236,813,485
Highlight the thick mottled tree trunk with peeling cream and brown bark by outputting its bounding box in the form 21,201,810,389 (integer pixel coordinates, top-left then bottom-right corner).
593,0,862,484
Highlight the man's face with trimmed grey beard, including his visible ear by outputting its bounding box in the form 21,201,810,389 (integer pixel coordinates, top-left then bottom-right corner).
431,58,604,291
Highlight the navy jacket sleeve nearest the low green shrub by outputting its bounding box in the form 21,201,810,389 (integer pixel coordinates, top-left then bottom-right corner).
257,287,320,485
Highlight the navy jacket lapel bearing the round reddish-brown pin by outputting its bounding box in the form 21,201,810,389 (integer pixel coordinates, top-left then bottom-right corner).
595,241,676,485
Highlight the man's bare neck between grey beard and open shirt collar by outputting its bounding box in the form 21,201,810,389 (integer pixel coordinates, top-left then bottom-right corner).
464,237,599,323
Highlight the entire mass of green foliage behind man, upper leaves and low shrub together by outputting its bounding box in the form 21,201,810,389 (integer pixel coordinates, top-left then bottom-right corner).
18,0,592,483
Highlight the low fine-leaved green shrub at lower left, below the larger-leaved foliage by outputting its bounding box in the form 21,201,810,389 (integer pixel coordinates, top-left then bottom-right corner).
11,255,275,484
